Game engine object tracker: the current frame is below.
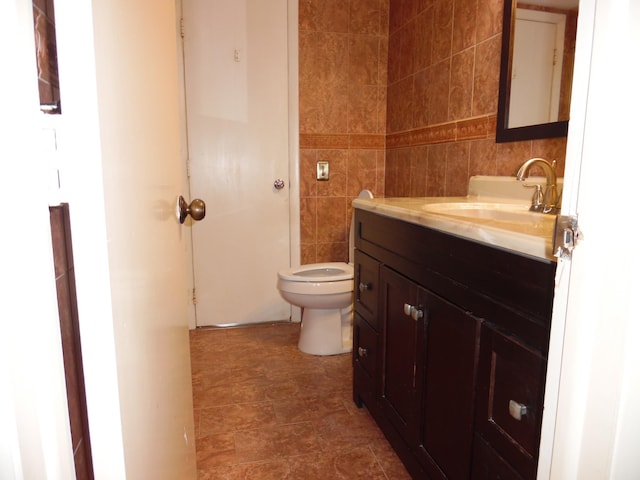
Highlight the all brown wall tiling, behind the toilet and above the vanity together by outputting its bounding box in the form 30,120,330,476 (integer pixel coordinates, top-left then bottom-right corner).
299,0,566,263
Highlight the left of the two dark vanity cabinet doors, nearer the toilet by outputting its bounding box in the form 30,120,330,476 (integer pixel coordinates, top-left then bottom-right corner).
379,267,424,445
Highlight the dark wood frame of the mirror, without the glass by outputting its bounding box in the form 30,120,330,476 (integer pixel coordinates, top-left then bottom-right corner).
496,0,569,143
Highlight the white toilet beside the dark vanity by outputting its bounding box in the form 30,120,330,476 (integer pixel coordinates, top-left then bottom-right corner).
278,190,373,355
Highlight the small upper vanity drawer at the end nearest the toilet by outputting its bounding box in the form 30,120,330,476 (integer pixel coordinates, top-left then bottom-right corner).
353,250,380,330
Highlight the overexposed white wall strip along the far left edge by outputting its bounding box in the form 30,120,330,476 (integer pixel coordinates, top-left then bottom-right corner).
0,0,74,480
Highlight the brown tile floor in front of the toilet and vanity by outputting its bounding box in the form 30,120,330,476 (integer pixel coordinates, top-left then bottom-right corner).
191,323,410,480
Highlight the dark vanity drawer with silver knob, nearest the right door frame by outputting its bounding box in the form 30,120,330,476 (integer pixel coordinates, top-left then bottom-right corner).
475,324,546,479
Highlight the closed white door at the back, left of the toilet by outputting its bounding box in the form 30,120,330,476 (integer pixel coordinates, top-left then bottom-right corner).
183,0,290,326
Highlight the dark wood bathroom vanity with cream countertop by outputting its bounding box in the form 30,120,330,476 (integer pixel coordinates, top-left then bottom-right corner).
353,193,556,479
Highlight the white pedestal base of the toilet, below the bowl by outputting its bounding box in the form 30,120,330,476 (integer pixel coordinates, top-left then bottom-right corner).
298,307,353,356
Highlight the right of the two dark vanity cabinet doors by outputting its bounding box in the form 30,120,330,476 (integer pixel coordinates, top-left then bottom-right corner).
417,289,481,480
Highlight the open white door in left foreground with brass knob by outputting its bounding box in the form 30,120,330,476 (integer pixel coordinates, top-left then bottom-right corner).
41,0,196,480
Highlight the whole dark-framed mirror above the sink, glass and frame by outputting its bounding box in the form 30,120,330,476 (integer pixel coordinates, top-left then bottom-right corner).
496,0,579,143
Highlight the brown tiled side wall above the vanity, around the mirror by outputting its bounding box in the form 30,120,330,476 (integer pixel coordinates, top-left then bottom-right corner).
385,0,566,197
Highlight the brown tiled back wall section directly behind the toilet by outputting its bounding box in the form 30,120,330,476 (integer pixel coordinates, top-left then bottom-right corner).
299,0,389,263
